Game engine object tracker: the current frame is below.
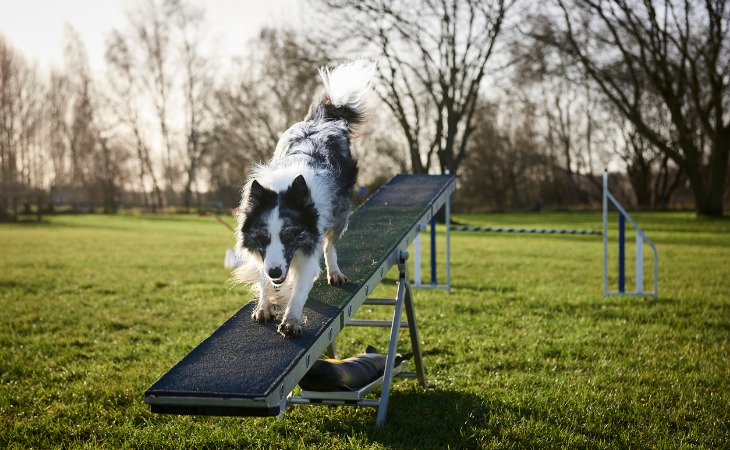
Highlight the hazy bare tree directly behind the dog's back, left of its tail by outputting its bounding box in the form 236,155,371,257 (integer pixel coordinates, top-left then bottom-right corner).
208,28,330,204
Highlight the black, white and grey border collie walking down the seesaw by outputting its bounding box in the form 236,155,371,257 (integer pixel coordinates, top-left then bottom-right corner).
233,61,375,337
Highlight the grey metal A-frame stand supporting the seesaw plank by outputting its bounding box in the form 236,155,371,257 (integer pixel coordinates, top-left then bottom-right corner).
279,250,428,427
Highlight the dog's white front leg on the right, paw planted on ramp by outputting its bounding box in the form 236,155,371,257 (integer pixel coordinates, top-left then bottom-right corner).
278,253,321,338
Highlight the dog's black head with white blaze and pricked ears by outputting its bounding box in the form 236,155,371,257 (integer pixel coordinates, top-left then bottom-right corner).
241,175,319,287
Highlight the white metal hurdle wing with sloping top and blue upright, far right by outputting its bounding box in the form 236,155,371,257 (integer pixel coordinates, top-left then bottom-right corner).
603,170,659,299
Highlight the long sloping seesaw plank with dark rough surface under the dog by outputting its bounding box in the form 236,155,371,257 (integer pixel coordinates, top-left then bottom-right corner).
145,175,455,416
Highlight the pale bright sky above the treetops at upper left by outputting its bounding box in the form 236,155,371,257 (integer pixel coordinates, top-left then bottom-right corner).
0,0,304,70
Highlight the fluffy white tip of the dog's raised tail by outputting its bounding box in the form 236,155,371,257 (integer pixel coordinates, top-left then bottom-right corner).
319,60,376,122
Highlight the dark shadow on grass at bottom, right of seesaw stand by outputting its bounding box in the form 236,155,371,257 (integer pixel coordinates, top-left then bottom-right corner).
358,387,621,449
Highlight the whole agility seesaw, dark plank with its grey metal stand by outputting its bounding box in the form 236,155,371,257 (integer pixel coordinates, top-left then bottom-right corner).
144,175,456,426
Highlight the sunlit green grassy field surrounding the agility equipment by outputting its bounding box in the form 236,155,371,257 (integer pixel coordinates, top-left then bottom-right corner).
0,213,730,449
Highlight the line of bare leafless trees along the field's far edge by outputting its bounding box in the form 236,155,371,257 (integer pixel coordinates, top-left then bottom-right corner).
0,0,730,219
